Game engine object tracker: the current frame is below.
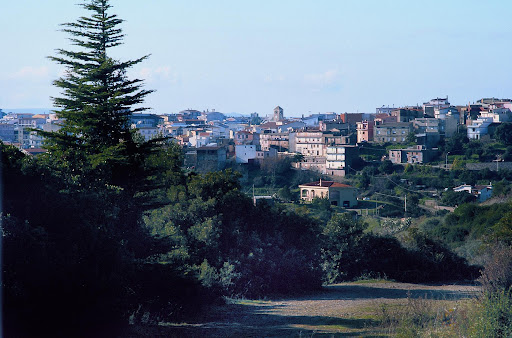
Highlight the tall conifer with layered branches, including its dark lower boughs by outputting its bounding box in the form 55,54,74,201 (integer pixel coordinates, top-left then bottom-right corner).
41,0,182,255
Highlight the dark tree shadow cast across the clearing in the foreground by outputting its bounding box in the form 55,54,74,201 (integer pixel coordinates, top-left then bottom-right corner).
123,284,474,337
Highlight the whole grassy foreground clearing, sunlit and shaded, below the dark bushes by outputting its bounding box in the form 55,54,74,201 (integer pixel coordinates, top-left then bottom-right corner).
122,281,477,337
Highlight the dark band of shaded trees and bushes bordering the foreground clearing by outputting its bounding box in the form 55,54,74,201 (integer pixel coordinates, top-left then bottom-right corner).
2,141,475,332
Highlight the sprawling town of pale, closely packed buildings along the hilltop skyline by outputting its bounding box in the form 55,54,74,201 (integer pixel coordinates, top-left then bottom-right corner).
0,97,512,211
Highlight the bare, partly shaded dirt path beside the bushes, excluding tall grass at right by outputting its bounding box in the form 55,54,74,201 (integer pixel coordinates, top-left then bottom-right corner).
125,283,478,337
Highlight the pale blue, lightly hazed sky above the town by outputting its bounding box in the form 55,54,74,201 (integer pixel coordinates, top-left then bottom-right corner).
0,0,512,117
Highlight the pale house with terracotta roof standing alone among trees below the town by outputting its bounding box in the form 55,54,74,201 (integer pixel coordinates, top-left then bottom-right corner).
299,180,358,208
